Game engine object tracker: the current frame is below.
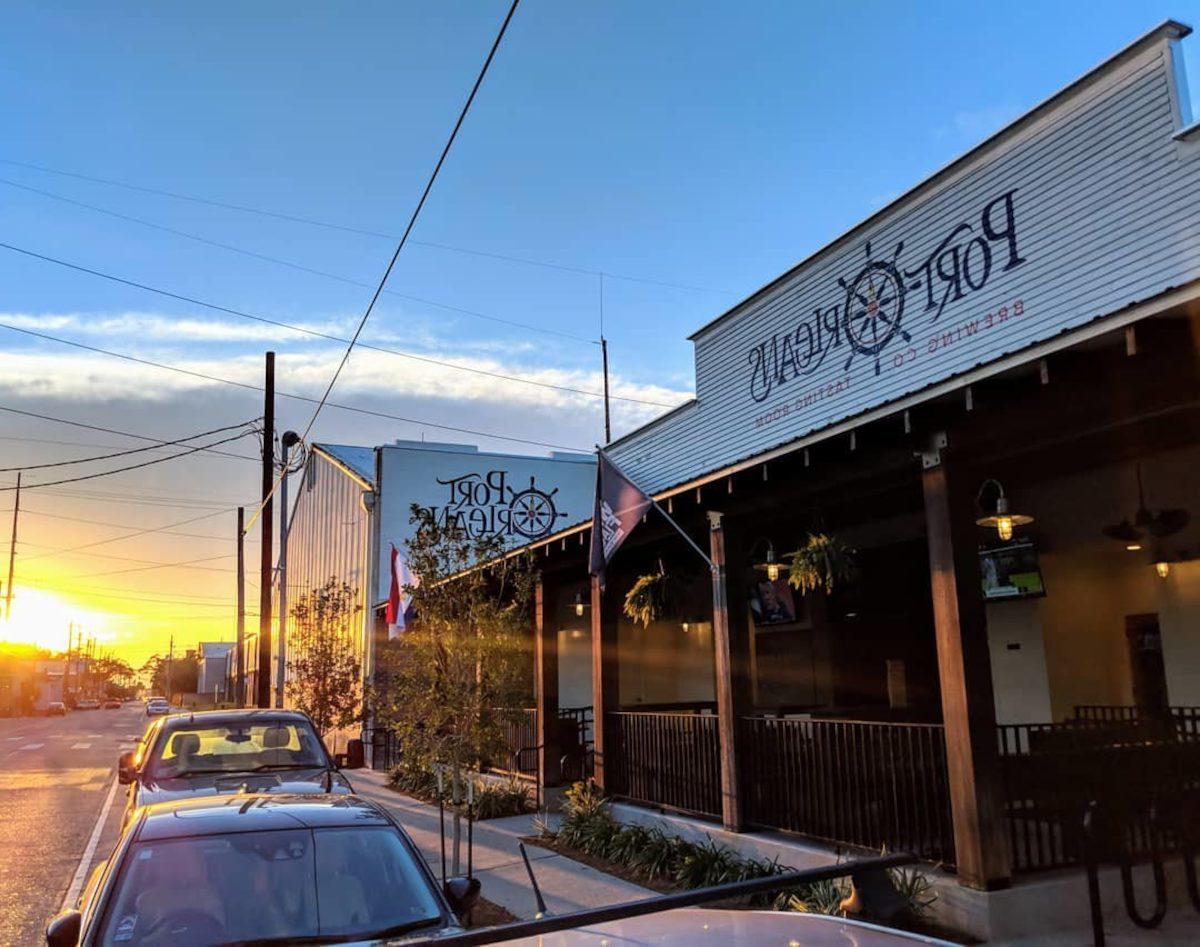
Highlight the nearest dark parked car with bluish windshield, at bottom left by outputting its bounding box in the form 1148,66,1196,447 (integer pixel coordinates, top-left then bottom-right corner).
46,793,479,947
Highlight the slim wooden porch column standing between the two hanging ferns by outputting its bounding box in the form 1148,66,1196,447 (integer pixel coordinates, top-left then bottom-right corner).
708,513,750,832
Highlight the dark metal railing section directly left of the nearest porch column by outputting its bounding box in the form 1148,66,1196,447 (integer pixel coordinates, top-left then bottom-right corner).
739,717,954,865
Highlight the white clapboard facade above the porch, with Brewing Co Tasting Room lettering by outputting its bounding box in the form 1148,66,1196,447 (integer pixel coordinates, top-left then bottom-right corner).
610,24,1200,491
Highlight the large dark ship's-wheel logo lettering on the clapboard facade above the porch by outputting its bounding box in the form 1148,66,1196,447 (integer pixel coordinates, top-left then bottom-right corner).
746,188,1025,401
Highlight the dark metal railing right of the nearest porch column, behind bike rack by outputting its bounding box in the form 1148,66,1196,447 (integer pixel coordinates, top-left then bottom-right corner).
997,708,1200,871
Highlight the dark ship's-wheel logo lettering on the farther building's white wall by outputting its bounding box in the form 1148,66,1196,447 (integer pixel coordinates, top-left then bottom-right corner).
430,470,566,539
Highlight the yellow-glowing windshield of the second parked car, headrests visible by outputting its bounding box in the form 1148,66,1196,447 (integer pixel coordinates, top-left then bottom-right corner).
149,720,328,779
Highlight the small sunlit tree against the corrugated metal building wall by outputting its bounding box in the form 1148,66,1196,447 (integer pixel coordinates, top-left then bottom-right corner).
287,579,362,737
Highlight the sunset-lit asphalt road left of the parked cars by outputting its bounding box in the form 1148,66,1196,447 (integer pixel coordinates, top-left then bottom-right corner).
0,703,146,947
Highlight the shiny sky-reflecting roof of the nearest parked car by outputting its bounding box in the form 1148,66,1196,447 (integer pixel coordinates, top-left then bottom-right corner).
137,793,395,841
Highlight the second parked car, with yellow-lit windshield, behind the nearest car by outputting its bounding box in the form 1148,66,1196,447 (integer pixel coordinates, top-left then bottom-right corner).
118,711,362,819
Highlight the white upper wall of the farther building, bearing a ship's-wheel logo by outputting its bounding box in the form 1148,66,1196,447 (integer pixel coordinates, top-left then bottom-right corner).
377,442,595,600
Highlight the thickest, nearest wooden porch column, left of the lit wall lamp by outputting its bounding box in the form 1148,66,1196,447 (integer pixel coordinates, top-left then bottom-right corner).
922,436,1012,889
